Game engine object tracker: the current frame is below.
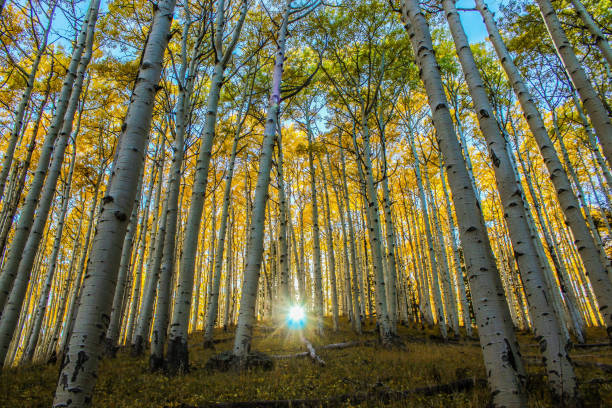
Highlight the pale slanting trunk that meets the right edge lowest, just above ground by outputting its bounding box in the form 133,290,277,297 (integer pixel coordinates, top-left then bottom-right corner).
476,0,612,338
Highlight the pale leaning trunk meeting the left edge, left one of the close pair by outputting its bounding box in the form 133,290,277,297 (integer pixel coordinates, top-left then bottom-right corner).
0,0,100,308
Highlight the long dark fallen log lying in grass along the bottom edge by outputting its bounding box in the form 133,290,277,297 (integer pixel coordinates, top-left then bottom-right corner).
179,378,487,408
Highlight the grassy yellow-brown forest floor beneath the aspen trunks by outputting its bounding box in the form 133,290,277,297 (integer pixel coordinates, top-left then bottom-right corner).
0,323,612,408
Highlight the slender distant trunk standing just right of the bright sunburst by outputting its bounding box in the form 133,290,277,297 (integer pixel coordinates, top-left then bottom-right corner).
306,127,324,334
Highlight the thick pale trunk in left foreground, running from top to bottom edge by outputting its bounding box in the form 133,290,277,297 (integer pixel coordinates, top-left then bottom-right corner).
53,0,175,407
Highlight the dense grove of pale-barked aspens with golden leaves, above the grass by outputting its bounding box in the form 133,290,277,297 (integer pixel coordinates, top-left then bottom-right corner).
0,0,612,407
